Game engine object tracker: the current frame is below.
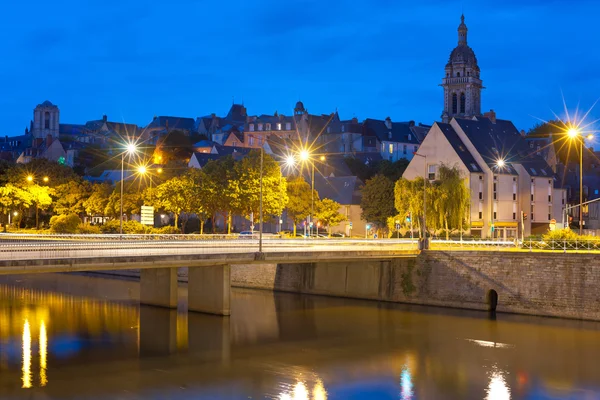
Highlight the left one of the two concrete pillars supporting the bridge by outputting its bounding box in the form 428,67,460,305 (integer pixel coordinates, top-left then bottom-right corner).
140,268,177,308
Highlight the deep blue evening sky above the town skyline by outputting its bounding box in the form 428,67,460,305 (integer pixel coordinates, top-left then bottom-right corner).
0,0,600,136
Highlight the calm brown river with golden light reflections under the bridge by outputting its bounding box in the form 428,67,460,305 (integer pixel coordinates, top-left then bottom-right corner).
0,274,600,400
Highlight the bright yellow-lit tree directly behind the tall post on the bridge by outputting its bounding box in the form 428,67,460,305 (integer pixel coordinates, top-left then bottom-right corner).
229,150,288,228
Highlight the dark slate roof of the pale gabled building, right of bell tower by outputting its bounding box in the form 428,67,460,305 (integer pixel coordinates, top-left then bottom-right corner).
455,117,553,177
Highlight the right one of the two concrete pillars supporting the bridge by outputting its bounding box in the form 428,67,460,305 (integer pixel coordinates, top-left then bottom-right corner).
188,265,231,315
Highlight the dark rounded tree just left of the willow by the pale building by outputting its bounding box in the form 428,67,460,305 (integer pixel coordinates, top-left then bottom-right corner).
360,174,396,233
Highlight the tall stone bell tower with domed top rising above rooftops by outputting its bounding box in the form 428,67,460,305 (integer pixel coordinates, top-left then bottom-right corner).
440,15,483,123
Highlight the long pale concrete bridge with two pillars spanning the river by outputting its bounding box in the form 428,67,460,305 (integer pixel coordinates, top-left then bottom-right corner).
0,235,418,315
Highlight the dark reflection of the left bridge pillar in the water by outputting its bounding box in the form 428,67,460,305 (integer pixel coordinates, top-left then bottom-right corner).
140,306,177,356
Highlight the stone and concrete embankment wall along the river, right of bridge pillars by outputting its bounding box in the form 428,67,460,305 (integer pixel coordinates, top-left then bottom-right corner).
231,251,600,320
